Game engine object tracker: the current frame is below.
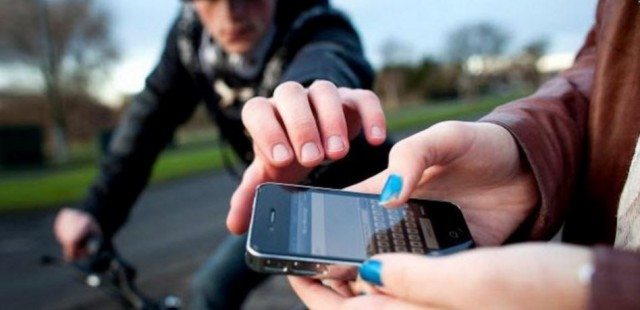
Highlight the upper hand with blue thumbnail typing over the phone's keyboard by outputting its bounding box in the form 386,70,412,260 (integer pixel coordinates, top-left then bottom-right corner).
349,121,539,245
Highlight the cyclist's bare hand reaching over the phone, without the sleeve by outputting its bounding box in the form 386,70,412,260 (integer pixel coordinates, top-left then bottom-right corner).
227,81,386,233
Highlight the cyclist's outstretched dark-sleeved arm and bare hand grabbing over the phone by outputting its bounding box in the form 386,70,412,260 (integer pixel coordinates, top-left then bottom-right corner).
227,8,390,233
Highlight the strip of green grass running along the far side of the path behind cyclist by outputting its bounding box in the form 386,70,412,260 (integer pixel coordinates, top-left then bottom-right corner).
0,94,521,211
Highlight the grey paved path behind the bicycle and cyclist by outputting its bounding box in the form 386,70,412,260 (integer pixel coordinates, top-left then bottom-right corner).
0,173,298,309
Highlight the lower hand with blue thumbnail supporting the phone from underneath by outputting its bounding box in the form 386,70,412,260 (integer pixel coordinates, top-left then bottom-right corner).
289,243,593,309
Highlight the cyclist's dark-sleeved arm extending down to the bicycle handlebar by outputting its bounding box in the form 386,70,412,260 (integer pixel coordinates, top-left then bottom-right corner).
81,18,198,236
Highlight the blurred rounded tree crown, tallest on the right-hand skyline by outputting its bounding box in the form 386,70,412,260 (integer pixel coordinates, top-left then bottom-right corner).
446,22,509,62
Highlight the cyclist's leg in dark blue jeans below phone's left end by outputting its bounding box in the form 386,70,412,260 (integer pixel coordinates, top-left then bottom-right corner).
191,235,268,309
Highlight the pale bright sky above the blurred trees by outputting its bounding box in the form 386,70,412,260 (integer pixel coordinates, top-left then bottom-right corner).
0,0,596,103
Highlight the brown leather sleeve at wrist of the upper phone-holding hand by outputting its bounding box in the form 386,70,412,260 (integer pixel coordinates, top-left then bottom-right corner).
480,26,597,240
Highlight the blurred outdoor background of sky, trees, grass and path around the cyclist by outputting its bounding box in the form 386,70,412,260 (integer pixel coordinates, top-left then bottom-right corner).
0,0,596,309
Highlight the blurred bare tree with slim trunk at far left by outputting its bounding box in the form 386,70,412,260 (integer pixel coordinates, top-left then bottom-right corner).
0,0,118,161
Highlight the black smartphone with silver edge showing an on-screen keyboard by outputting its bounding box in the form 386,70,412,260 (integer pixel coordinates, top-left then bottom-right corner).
246,183,474,280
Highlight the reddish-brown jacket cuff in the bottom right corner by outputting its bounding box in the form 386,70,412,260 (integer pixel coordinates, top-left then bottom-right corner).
589,246,640,309
